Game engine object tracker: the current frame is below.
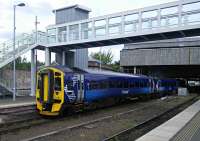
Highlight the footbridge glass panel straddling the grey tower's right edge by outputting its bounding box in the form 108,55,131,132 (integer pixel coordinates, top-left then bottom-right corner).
81,22,92,39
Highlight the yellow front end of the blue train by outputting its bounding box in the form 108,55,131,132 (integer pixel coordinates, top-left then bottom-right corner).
36,67,64,116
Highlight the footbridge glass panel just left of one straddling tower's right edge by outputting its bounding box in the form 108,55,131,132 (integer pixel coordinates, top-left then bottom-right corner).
69,24,79,41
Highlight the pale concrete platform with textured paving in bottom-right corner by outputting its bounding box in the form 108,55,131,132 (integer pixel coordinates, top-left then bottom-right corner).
136,100,200,141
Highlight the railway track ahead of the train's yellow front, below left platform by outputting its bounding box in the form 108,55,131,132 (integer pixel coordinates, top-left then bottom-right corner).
0,105,44,135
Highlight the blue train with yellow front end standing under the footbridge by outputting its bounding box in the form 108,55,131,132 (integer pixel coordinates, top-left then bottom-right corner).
36,66,178,116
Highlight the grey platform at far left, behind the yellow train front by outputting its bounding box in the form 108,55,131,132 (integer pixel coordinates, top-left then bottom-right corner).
0,96,35,109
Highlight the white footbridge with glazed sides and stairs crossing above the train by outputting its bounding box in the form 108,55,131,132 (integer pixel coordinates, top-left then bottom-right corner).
0,0,200,94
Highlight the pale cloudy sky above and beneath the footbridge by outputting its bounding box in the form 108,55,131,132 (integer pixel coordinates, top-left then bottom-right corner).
0,0,175,61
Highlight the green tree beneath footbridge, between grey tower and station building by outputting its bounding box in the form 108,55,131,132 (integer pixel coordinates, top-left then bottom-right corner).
90,50,113,65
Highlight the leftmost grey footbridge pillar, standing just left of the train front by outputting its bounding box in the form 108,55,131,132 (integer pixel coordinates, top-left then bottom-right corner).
30,49,37,96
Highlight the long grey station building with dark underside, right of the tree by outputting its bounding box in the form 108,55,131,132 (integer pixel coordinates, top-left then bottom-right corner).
120,37,200,79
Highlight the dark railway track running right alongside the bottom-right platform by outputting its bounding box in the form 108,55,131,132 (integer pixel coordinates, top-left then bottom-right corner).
103,97,199,141
